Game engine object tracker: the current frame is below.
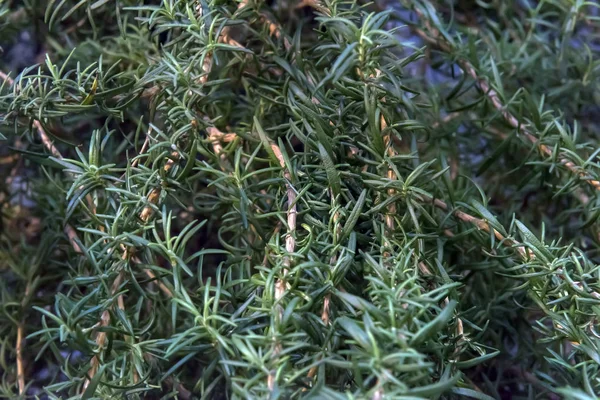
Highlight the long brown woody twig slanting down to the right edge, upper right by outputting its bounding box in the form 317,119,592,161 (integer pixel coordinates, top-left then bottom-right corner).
413,8,600,194
